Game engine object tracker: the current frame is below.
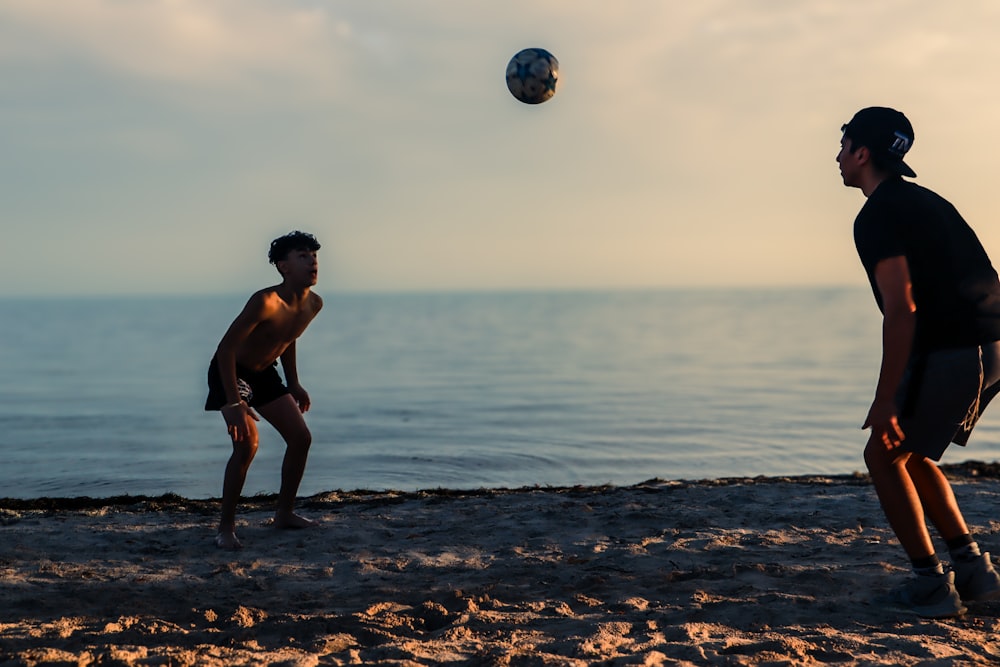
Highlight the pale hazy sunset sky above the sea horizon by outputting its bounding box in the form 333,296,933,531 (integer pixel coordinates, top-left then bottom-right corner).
0,0,1000,296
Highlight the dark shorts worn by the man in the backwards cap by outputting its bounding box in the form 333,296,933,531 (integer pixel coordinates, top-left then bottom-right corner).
896,342,1000,461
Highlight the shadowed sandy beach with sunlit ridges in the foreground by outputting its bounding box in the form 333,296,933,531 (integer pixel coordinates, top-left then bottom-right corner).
0,464,1000,666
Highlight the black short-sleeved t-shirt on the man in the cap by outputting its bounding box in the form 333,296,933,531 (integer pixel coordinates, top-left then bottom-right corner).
854,177,1000,353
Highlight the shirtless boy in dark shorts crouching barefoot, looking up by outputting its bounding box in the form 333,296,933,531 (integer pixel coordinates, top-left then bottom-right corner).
205,232,323,549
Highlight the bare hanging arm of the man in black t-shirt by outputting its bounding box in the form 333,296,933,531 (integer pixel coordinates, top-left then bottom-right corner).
862,256,917,448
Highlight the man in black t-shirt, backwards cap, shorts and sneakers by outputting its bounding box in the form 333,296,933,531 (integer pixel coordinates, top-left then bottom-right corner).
837,107,1000,617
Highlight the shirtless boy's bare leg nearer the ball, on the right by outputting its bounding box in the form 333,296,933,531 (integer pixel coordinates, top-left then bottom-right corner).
257,394,316,528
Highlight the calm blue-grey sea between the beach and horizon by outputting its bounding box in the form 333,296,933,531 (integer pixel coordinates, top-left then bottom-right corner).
0,287,1000,498
